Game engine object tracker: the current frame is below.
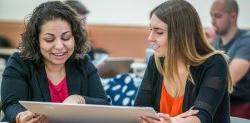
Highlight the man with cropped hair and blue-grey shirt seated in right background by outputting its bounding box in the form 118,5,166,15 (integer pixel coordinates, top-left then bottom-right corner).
210,0,250,119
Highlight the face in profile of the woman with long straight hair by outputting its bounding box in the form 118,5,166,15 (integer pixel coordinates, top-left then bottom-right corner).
148,14,168,57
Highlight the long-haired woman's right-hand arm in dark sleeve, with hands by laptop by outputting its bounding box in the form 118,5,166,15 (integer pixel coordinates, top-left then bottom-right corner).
139,55,229,123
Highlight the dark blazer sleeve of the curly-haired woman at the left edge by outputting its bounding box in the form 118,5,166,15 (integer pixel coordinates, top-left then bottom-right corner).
1,53,28,123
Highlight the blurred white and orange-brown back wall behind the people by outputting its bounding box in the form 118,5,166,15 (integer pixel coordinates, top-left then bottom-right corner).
0,0,250,58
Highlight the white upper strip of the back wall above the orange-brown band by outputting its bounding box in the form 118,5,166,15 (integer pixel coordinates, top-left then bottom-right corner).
0,0,250,28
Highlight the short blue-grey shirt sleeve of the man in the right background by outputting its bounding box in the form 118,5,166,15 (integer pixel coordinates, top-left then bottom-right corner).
235,36,250,61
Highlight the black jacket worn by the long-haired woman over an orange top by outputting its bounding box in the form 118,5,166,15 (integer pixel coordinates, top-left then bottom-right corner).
135,55,230,123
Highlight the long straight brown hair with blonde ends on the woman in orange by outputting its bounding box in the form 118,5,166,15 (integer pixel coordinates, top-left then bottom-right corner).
150,0,232,96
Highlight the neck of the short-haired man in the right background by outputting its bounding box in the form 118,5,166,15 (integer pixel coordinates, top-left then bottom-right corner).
221,26,238,45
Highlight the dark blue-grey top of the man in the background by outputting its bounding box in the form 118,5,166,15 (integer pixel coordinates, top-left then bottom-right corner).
214,30,250,103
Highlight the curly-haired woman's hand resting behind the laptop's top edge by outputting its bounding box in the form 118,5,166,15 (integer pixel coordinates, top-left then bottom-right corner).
63,95,85,104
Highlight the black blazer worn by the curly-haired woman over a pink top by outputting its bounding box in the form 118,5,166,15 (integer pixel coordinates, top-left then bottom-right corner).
1,53,109,122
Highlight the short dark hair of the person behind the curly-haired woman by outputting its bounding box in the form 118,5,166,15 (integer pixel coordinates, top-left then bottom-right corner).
64,0,89,15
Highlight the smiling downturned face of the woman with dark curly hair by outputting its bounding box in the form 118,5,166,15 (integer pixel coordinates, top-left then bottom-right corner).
39,19,75,66
